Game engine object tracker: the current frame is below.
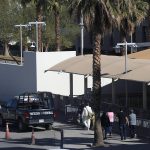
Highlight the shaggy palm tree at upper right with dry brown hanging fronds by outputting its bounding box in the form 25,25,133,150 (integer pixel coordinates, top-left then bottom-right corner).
117,0,148,54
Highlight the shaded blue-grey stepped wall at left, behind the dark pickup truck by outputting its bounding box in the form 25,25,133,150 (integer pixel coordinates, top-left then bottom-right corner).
0,53,36,100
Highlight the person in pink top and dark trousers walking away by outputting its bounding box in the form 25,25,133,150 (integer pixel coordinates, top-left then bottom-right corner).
107,108,115,136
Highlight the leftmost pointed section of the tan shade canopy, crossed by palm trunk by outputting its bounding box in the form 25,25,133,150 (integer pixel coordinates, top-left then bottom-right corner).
46,54,121,75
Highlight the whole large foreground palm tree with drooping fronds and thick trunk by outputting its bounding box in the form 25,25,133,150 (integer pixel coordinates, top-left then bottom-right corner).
70,0,118,146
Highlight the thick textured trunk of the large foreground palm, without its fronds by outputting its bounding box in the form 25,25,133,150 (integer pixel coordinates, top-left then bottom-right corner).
93,33,104,146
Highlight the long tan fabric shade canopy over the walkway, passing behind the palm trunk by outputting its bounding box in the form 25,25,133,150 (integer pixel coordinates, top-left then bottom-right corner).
46,54,150,82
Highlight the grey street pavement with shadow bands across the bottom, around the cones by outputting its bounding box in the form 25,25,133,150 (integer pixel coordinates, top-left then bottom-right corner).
0,122,150,150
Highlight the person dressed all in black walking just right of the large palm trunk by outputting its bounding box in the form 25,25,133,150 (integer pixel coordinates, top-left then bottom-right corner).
101,112,110,139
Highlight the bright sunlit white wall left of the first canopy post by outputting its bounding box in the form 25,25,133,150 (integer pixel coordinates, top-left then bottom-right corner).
36,51,76,95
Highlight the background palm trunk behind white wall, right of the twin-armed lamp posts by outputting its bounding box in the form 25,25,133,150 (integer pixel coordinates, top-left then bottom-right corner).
55,11,60,51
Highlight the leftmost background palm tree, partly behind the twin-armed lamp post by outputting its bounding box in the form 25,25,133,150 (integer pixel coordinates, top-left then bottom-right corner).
21,0,48,51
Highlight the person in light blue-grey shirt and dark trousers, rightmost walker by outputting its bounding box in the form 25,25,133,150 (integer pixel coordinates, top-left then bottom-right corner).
129,109,136,138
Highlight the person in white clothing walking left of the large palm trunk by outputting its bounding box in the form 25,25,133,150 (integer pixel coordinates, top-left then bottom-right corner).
82,103,93,130
